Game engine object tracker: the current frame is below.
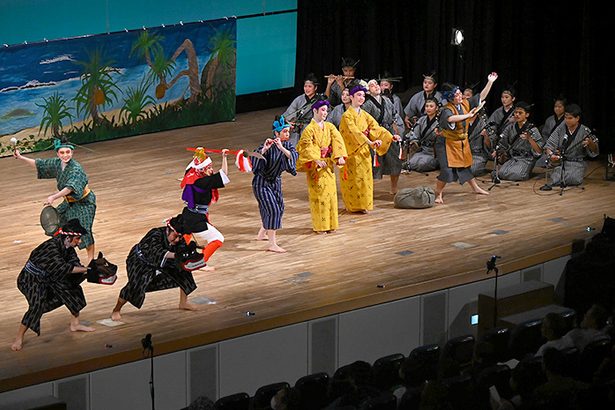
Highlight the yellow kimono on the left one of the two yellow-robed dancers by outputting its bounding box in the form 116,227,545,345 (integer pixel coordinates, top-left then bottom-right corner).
297,120,347,232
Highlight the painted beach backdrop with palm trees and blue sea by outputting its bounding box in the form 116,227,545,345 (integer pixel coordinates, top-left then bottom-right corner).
0,19,237,156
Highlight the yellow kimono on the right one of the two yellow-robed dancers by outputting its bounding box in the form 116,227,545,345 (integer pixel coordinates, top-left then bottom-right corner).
340,107,393,212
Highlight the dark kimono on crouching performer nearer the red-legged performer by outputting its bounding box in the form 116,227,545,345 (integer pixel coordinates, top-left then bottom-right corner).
120,227,196,309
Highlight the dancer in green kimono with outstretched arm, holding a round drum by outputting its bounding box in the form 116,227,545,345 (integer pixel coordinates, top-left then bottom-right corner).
13,139,96,262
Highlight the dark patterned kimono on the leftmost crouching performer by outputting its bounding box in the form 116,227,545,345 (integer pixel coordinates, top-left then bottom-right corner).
17,236,86,335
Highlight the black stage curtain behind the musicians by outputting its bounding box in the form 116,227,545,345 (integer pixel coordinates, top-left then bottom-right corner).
296,0,615,152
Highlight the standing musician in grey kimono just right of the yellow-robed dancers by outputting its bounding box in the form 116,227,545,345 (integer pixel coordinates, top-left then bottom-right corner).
361,80,404,194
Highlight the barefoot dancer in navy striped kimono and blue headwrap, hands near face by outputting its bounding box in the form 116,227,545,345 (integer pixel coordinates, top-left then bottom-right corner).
252,114,298,253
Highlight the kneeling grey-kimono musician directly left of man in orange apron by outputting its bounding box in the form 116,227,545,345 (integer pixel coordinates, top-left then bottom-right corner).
406,97,438,172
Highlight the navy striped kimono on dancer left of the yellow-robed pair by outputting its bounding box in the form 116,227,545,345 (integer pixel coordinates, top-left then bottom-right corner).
252,141,299,229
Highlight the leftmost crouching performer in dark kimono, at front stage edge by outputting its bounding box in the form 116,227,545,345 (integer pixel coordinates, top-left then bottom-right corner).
11,219,94,351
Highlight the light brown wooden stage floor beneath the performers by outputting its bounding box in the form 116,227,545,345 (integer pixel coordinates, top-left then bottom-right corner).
0,109,615,392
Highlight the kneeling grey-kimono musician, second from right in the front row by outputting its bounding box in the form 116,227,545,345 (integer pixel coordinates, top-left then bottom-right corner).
493,101,544,181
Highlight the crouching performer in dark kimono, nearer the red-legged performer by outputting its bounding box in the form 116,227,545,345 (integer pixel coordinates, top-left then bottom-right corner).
111,215,197,321
